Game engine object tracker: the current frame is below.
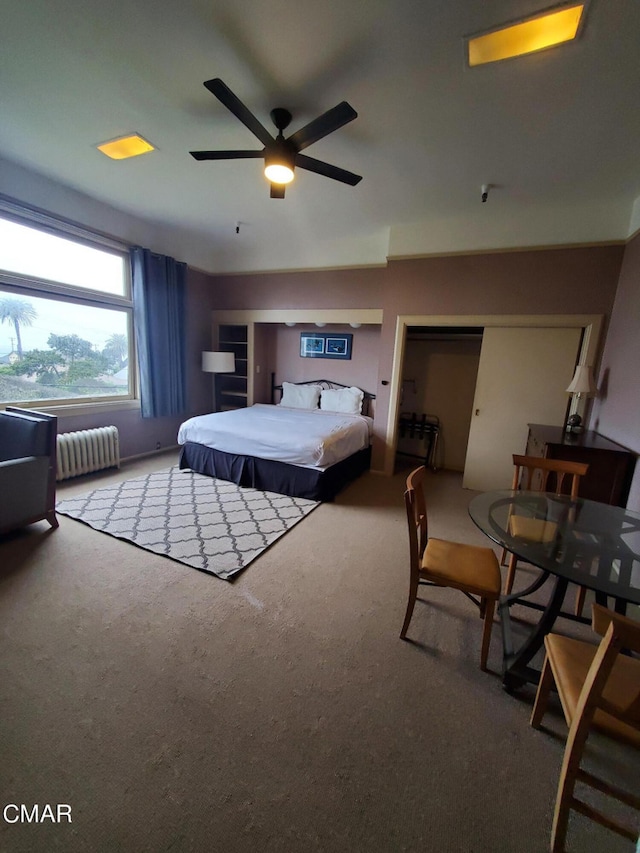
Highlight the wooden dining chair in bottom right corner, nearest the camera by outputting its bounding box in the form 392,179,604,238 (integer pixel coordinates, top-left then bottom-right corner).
531,604,640,853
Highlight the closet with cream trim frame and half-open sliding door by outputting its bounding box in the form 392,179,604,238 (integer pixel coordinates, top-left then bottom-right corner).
384,314,603,480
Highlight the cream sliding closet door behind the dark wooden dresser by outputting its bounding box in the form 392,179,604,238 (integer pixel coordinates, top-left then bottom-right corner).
462,327,582,491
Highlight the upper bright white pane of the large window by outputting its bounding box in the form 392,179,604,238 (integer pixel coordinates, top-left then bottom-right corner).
0,217,126,296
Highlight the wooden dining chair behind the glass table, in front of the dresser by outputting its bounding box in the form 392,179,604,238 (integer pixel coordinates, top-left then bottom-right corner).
501,453,589,604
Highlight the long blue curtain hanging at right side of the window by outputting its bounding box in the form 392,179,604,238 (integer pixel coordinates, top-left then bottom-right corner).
131,246,187,418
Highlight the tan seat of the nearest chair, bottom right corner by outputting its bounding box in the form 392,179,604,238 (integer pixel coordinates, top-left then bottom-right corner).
545,634,640,747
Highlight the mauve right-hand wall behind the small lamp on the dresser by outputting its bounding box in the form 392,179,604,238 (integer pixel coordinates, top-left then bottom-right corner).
589,235,640,512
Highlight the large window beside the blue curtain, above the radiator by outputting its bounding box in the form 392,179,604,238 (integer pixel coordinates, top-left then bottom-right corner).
0,201,135,407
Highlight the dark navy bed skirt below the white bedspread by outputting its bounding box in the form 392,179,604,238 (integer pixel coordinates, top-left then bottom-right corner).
179,441,371,501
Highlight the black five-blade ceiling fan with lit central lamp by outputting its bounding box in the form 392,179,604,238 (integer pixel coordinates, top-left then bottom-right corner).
189,77,362,198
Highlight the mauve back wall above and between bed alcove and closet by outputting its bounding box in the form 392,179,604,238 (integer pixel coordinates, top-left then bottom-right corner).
208,246,624,467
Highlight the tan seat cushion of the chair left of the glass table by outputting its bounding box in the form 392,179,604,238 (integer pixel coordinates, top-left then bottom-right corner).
422,539,501,598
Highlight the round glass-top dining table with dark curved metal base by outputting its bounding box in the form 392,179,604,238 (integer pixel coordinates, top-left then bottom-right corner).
469,490,640,690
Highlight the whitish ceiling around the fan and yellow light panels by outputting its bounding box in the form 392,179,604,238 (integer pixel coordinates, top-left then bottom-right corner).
0,0,640,272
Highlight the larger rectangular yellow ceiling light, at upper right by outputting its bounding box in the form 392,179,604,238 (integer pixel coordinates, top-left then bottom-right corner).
467,3,585,67
